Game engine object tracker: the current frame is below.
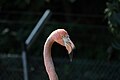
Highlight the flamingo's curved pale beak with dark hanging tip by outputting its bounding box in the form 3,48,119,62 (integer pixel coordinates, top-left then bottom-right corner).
63,36,75,62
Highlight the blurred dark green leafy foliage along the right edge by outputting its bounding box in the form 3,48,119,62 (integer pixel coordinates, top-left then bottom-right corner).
104,0,120,49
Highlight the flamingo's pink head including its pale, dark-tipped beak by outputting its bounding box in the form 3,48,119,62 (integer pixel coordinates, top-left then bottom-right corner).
52,29,75,61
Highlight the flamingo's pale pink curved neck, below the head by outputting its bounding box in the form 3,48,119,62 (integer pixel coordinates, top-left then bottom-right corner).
43,38,58,80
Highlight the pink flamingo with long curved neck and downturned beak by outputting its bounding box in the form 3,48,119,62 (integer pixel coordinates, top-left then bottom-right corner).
43,29,75,80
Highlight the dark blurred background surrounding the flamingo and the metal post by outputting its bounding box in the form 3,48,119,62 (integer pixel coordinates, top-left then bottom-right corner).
0,0,120,80
